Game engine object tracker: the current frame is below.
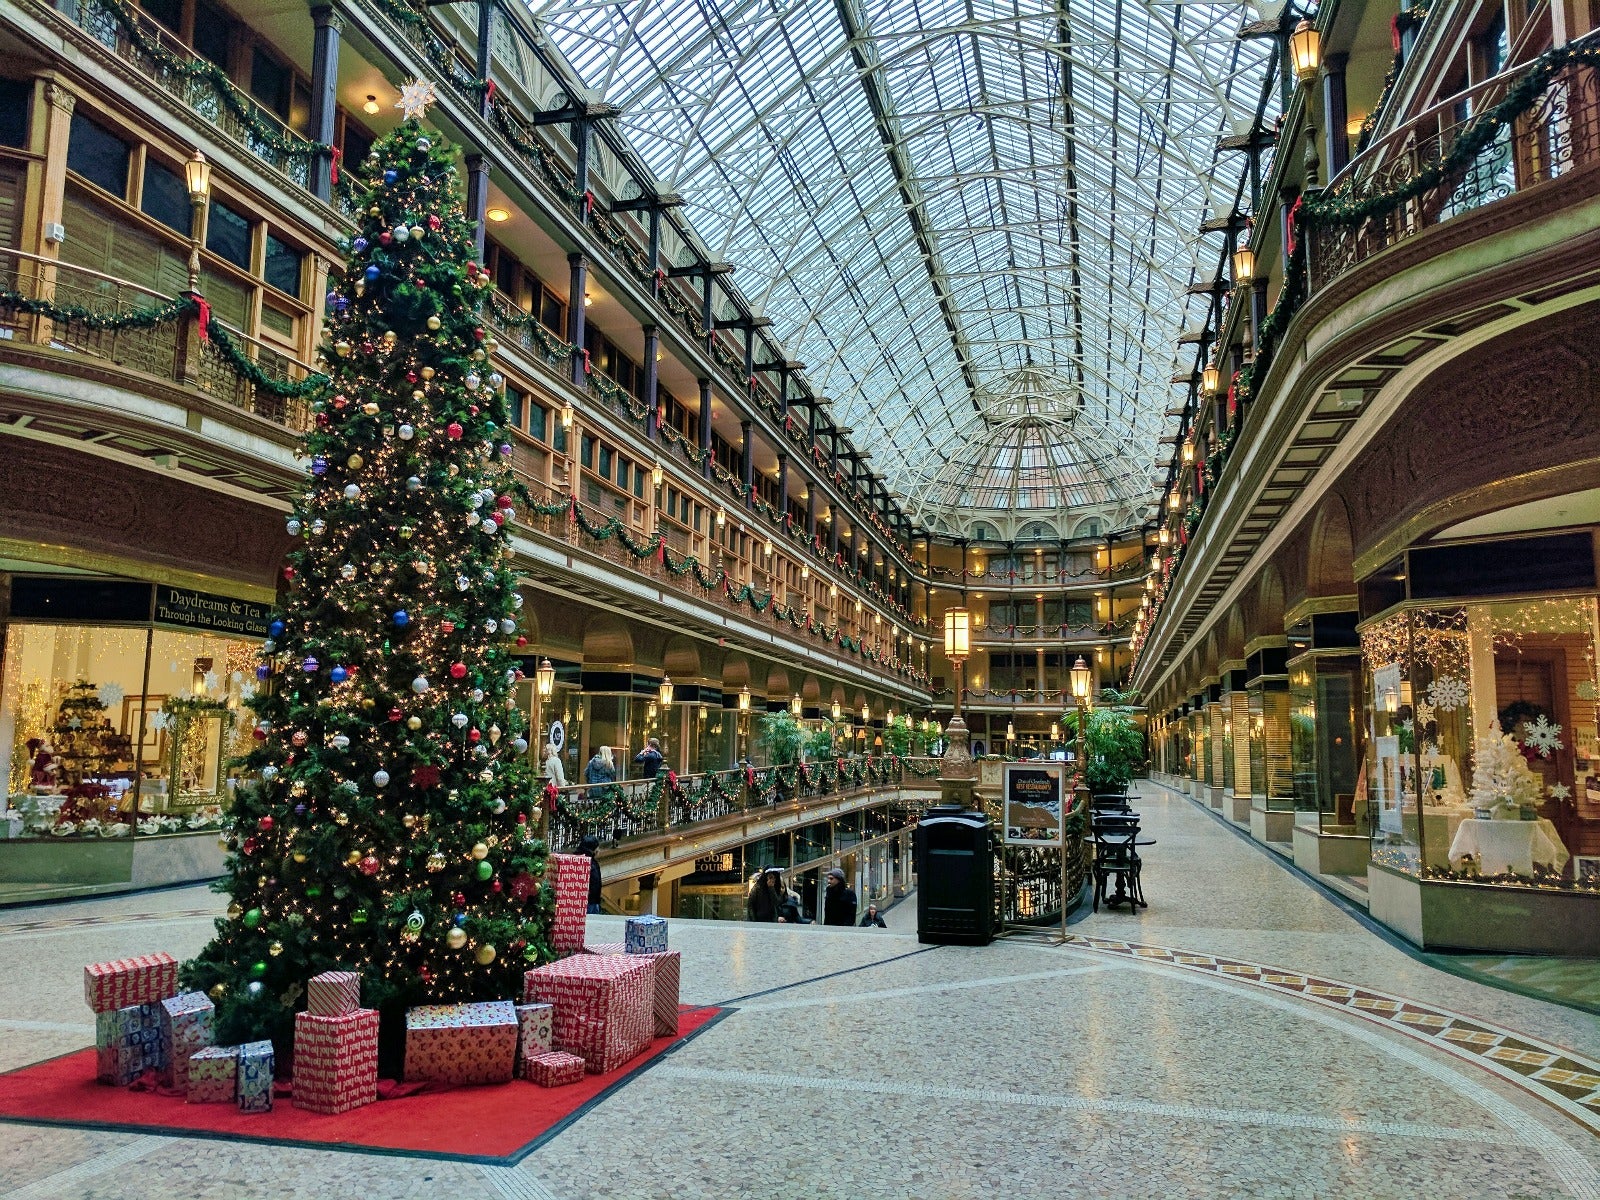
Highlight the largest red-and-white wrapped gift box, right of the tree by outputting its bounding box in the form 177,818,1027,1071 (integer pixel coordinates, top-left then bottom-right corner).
523,954,656,1075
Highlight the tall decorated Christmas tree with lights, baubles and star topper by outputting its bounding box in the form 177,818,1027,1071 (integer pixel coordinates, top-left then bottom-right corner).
184,85,554,1066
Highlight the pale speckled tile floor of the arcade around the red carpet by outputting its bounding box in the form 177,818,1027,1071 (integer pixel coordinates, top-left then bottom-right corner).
0,789,1600,1200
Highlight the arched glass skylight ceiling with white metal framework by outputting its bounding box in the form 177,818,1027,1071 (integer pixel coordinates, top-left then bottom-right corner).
533,0,1278,536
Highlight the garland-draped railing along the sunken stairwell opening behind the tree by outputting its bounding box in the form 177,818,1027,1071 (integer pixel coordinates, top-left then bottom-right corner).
544,755,939,850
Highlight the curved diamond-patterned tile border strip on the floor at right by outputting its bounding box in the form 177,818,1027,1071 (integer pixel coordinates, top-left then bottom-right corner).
1067,933,1600,1136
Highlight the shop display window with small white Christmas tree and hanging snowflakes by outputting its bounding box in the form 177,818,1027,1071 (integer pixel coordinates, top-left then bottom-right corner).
1357,595,1600,888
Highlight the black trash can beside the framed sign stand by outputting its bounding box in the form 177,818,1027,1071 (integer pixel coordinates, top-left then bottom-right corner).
917,805,995,946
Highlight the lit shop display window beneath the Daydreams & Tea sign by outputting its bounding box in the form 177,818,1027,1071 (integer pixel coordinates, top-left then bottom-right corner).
0,622,259,838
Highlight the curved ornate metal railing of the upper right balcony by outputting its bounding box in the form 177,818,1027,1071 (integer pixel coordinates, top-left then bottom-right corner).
1309,51,1600,291
